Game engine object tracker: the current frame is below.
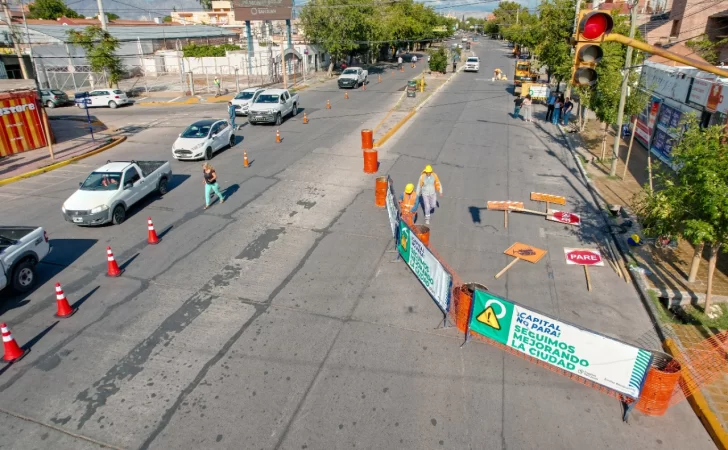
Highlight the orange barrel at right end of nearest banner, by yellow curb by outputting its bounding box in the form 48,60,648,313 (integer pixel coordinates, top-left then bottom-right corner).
635,351,682,416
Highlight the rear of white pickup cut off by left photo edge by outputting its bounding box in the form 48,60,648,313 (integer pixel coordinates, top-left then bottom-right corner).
0,226,51,292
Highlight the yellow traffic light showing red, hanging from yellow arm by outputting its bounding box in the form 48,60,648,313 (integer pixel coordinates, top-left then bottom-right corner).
571,11,614,86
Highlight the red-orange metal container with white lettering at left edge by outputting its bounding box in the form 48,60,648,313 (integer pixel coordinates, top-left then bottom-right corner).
0,91,47,156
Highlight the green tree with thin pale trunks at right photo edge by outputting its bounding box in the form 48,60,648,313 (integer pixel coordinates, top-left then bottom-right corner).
636,114,728,312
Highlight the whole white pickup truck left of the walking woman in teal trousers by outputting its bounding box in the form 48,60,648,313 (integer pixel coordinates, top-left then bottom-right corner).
61,161,172,225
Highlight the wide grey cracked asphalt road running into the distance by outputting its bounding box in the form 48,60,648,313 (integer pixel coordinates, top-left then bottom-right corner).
0,42,712,449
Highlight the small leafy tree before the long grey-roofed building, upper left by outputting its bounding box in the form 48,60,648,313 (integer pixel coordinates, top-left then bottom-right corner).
66,26,124,87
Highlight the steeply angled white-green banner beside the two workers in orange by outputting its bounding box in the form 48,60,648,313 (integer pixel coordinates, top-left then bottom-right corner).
397,221,452,313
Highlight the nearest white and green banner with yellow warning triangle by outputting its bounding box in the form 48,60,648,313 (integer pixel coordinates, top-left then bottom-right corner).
470,290,652,399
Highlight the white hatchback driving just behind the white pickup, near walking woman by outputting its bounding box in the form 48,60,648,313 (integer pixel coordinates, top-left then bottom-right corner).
172,119,235,161
